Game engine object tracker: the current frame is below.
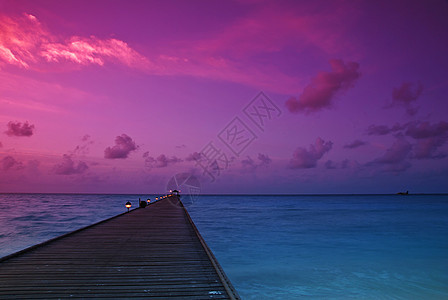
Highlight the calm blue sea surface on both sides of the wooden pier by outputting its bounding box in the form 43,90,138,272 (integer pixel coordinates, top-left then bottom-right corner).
0,194,448,299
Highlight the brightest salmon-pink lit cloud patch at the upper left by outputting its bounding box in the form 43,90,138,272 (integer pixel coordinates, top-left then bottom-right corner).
0,14,149,68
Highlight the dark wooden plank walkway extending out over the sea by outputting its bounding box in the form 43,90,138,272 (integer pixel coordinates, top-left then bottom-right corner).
0,196,239,299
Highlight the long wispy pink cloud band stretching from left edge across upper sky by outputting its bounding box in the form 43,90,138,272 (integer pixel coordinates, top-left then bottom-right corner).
0,2,356,94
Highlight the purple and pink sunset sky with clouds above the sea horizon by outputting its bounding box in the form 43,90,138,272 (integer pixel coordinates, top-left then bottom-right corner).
0,0,448,194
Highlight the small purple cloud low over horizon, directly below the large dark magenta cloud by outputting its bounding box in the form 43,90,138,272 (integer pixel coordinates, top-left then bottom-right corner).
289,138,333,169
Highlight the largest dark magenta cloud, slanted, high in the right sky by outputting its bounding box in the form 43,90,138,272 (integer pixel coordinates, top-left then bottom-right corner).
286,59,361,113
